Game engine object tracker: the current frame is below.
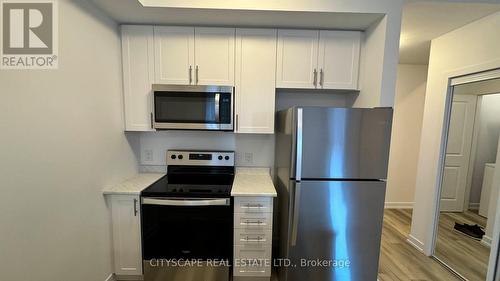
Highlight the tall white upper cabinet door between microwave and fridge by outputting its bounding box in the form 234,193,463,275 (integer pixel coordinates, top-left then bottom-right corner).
235,29,276,134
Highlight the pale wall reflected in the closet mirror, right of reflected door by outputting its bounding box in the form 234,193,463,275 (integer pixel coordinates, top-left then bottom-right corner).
470,94,500,203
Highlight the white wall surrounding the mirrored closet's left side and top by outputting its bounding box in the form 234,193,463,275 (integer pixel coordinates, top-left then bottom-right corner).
410,13,500,255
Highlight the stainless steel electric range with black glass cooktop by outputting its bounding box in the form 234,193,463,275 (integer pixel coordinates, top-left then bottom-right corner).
141,150,234,281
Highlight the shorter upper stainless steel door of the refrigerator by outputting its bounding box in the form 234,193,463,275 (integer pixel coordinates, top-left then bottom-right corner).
291,107,392,179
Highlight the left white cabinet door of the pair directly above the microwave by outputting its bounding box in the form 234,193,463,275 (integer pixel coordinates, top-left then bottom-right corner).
154,26,194,85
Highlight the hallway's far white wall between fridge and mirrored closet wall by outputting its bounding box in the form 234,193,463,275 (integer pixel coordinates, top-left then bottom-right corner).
385,64,427,208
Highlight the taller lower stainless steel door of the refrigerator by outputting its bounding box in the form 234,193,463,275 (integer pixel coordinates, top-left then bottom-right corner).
285,181,385,281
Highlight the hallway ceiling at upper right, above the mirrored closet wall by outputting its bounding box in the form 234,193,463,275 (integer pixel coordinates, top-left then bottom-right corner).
399,0,500,64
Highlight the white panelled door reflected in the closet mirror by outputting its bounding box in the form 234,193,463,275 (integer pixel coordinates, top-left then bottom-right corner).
440,95,477,212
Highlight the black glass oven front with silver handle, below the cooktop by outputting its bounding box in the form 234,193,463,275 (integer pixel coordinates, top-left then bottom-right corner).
141,198,233,281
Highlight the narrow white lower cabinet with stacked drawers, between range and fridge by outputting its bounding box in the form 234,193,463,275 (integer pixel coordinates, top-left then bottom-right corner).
233,197,273,280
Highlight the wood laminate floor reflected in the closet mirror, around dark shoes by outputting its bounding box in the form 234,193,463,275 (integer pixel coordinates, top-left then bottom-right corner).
436,211,490,281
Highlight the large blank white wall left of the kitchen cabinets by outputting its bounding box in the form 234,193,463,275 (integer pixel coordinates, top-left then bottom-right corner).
0,0,137,281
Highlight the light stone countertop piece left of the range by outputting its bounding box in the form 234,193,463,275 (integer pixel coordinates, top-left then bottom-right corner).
103,173,165,195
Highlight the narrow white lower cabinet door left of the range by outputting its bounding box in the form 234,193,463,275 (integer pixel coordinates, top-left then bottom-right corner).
111,195,142,275
